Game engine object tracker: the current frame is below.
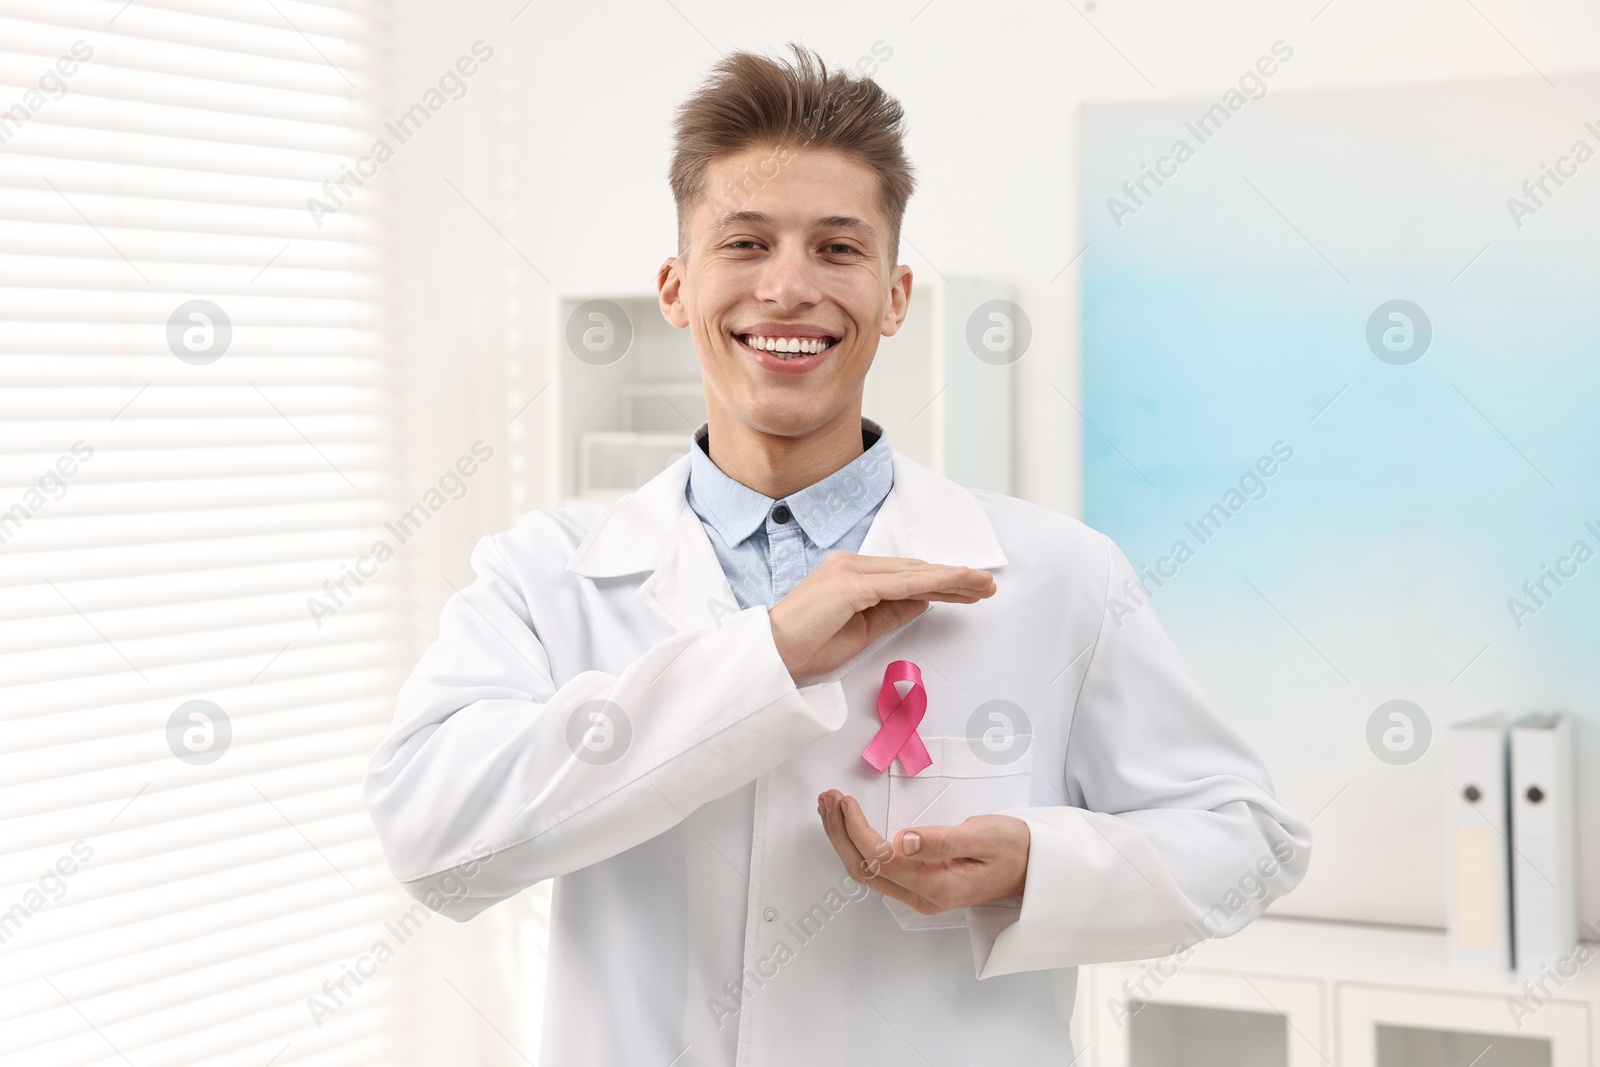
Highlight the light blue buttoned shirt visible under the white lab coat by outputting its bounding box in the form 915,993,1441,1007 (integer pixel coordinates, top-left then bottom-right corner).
685,418,894,608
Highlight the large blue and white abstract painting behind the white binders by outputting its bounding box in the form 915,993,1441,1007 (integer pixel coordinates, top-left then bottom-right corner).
1082,73,1600,926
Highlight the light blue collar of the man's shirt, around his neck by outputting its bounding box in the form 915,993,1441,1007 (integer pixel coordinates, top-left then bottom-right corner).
686,418,894,549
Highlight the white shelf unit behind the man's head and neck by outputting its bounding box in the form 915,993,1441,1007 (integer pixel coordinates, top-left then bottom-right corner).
547,278,1013,506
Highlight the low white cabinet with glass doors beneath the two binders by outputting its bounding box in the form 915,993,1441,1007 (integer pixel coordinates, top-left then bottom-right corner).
1074,917,1600,1067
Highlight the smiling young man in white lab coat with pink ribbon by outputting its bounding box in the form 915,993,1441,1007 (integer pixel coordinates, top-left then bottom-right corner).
366,50,1310,1067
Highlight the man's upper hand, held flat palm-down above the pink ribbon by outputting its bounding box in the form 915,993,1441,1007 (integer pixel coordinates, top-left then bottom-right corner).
768,552,995,678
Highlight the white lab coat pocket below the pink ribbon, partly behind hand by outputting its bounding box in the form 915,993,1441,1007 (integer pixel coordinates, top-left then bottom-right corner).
883,736,1034,929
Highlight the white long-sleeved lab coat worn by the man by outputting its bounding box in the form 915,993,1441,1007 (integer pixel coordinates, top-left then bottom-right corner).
366,453,1310,1067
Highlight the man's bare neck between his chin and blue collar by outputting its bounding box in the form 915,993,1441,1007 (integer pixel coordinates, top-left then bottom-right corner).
707,406,864,501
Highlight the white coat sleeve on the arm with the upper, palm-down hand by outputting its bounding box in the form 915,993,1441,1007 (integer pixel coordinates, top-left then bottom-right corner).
365,524,848,921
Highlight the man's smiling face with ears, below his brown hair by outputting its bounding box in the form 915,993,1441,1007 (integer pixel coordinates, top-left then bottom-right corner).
658,147,910,437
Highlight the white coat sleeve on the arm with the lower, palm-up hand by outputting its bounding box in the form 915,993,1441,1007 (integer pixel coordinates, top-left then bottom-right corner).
968,539,1310,977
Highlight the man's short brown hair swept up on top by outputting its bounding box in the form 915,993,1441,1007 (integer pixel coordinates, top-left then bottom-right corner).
670,45,915,266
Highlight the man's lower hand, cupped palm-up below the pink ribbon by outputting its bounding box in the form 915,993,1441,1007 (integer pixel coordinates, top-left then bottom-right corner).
816,789,1029,915
